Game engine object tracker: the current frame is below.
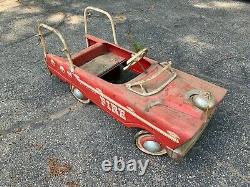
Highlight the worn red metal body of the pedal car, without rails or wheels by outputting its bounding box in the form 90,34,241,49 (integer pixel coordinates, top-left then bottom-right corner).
46,35,226,158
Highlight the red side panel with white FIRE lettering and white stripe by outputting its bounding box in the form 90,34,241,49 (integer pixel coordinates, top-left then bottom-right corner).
47,54,178,149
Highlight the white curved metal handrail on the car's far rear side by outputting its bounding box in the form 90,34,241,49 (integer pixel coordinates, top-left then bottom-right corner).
83,6,118,47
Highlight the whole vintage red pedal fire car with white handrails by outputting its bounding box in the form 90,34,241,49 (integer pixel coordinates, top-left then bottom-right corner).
38,7,226,158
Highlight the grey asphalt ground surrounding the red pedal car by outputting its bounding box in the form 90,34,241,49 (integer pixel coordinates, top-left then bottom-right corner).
0,0,250,186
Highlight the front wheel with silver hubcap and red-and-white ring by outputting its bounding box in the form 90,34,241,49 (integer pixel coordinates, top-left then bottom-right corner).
136,131,167,156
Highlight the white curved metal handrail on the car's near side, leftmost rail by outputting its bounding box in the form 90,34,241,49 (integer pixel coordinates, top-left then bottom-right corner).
38,23,74,72
